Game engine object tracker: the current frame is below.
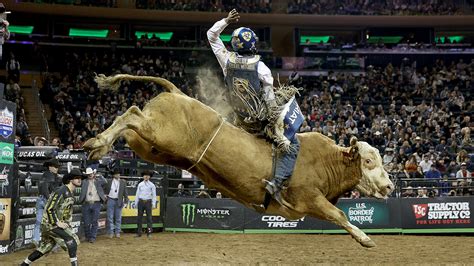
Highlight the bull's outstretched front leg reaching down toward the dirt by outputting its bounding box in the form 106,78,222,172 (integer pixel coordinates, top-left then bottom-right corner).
310,195,375,248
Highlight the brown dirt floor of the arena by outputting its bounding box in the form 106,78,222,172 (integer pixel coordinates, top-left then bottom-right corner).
0,233,474,265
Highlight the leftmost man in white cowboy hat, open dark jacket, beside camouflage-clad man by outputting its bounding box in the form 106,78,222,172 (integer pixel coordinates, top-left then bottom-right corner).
79,167,107,243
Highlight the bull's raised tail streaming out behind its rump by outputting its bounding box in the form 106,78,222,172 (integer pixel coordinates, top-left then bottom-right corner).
94,74,184,95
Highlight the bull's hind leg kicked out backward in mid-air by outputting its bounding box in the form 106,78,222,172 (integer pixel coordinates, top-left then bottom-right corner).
83,106,145,160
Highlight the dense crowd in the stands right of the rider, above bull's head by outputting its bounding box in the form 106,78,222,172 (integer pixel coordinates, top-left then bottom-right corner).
292,57,474,195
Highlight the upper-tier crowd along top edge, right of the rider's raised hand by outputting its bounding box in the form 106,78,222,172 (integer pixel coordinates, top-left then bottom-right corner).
287,0,472,16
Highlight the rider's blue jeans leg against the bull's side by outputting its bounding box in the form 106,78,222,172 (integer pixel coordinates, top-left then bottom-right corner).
273,136,300,187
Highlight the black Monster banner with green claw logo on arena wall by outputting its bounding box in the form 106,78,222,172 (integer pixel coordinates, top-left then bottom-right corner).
165,198,244,231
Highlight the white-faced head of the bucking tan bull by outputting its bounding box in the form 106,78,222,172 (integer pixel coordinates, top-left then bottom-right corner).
351,137,395,199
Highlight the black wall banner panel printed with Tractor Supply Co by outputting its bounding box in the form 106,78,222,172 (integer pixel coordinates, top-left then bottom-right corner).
401,197,474,231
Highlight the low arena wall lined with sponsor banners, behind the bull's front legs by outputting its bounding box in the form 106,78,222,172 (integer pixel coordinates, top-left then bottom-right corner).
164,197,474,234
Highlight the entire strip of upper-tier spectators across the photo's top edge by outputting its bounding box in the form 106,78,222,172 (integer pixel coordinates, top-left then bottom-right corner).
21,0,473,16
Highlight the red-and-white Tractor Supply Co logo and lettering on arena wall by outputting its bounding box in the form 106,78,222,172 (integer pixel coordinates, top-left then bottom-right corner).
412,201,471,224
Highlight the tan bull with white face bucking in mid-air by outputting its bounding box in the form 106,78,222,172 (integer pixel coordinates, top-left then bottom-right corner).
84,75,393,247
